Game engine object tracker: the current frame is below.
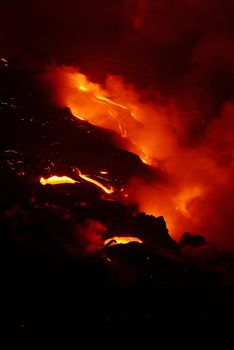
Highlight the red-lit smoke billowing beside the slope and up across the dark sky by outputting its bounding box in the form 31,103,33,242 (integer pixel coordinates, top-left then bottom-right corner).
0,0,234,248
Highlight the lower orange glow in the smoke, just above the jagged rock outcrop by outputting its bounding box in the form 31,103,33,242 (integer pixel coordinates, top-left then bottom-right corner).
128,180,206,239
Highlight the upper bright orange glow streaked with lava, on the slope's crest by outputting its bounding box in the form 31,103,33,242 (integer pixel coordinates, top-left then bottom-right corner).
44,68,149,157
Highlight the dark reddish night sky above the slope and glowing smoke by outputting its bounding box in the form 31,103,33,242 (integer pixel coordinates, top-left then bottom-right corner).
0,0,234,90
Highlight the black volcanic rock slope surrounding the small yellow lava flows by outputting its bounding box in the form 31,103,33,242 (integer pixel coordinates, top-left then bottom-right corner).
0,65,234,350
